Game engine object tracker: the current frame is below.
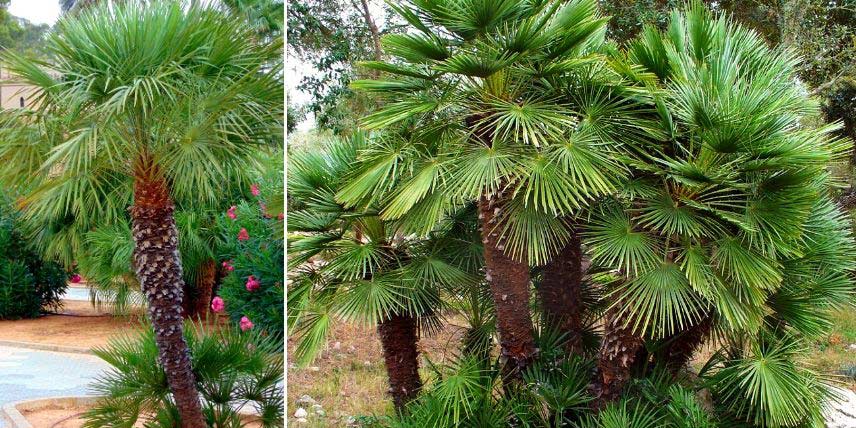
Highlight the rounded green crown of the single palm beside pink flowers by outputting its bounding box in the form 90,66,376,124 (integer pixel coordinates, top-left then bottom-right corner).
0,3,282,206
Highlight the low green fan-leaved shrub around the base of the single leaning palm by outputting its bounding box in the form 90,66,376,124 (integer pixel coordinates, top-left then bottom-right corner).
84,323,284,428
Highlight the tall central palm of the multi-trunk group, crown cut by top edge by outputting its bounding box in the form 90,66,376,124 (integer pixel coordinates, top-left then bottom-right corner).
344,0,645,380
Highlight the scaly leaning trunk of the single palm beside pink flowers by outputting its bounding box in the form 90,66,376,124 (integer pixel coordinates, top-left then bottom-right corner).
131,178,206,428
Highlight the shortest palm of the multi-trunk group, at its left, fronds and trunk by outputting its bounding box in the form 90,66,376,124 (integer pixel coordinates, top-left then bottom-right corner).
288,133,480,410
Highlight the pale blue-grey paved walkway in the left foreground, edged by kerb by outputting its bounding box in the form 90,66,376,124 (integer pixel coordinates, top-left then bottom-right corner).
0,346,108,427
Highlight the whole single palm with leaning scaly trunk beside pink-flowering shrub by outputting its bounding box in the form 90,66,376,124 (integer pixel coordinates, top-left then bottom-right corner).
0,2,283,427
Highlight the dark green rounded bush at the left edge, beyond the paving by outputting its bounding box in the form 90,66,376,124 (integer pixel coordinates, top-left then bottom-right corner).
0,194,67,319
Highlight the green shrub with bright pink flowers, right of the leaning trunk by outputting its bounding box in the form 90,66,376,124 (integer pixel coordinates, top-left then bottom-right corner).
211,192,285,341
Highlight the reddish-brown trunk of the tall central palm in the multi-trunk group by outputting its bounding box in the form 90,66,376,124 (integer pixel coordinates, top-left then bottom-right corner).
479,192,535,383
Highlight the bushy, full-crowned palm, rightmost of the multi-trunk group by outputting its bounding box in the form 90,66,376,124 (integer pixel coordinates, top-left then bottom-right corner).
586,3,853,412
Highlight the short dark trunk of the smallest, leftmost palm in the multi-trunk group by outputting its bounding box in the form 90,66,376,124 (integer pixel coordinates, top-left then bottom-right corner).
377,314,422,411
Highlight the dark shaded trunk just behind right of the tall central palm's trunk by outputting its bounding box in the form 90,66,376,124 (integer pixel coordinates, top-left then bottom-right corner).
538,233,583,354
